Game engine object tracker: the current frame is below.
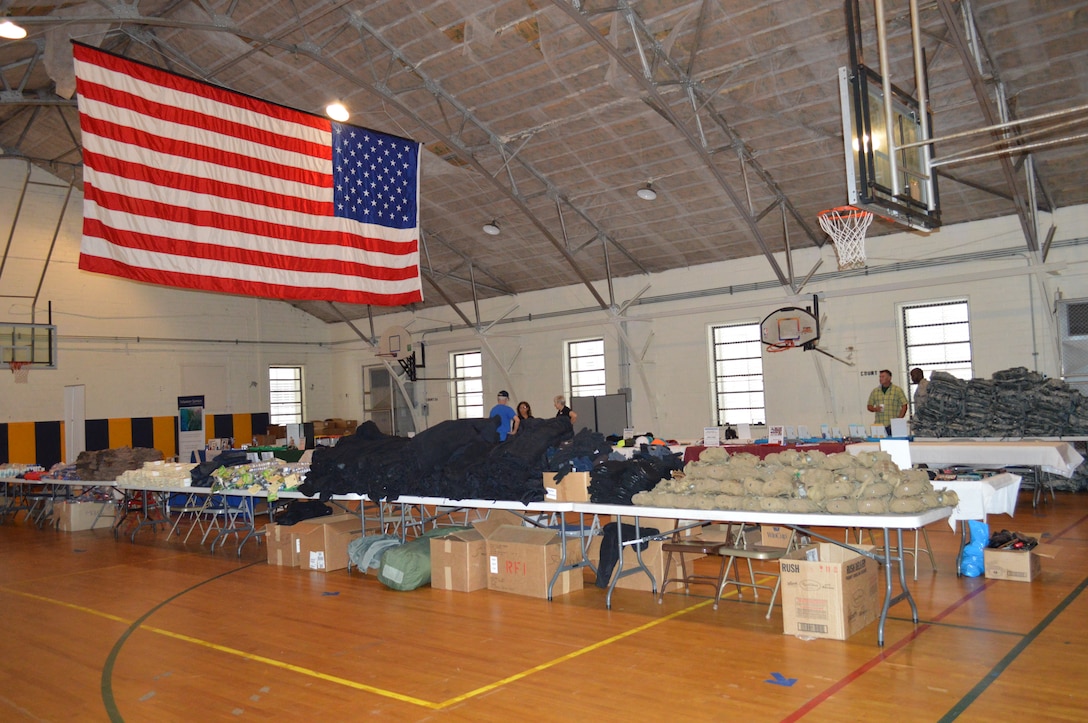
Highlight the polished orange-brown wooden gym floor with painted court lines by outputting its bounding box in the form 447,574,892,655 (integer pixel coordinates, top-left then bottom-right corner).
0,493,1088,722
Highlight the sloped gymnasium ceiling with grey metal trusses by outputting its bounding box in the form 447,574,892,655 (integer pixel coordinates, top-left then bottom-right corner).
0,0,1088,325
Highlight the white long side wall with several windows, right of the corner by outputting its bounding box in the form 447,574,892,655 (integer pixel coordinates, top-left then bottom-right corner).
336,208,1088,439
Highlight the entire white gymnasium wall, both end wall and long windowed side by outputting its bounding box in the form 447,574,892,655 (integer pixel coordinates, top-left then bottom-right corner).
8,159,1088,439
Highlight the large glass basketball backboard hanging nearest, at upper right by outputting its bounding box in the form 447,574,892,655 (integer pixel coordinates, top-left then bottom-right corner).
839,65,941,232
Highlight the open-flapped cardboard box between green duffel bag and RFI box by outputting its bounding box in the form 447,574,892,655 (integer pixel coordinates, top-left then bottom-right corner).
431,510,521,593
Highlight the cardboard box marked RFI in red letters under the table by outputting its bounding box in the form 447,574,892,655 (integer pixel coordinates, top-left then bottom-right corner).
487,525,582,599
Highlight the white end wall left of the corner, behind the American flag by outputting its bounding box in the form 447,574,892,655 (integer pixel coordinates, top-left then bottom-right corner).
0,159,334,422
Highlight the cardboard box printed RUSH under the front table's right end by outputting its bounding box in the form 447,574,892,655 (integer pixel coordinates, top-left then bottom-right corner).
780,543,881,640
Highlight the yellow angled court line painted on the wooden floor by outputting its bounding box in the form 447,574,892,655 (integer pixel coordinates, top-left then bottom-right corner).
0,574,770,710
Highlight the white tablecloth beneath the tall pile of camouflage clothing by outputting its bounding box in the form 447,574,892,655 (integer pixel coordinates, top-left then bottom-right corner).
846,440,1084,477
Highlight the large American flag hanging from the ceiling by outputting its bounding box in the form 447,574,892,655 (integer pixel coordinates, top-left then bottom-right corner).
74,43,423,306
